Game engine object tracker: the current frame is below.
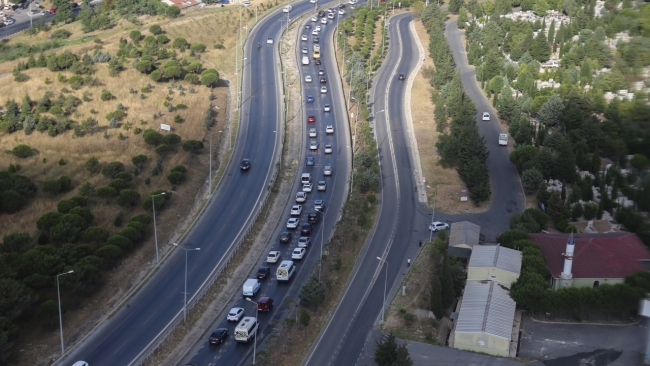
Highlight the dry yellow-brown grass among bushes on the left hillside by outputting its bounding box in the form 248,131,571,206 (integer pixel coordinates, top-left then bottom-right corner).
0,8,240,365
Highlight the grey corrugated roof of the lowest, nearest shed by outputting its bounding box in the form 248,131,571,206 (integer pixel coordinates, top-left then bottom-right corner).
456,281,516,340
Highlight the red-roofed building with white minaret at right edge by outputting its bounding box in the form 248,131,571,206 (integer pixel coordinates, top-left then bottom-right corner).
530,233,650,290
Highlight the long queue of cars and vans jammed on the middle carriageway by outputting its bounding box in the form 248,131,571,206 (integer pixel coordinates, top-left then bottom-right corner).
213,7,342,345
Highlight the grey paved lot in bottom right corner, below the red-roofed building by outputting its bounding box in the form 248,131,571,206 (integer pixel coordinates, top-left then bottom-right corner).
519,315,647,366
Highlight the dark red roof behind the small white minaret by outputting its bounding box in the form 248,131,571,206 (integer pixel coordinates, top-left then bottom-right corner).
530,233,650,278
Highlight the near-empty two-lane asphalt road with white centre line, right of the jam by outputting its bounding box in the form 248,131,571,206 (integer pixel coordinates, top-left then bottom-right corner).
303,14,430,365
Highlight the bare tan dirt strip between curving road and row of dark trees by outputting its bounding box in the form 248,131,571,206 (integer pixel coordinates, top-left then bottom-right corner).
411,20,489,214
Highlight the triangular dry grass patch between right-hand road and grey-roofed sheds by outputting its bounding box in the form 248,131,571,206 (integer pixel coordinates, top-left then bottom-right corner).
381,242,439,344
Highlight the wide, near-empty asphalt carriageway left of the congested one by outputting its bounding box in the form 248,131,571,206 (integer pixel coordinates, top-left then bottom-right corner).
56,4,292,366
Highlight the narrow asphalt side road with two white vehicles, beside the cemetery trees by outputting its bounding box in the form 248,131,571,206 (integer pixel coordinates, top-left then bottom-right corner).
445,21,525,241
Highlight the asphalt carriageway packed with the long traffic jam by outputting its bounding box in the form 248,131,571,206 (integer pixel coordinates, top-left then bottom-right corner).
177,2,350,365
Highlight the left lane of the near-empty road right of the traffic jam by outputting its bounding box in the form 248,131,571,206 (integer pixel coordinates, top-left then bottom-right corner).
303,12,408,365
